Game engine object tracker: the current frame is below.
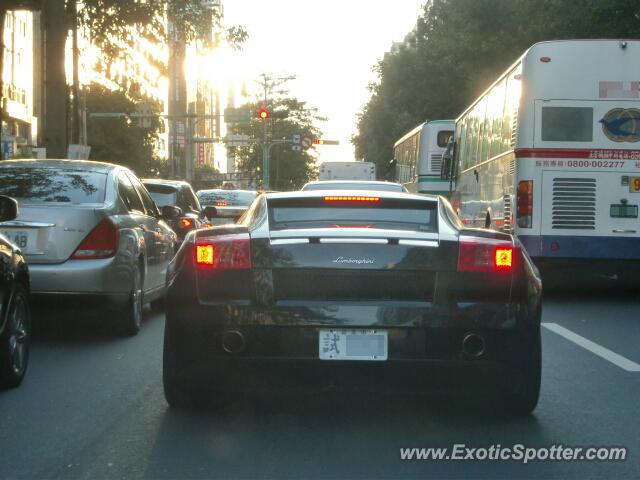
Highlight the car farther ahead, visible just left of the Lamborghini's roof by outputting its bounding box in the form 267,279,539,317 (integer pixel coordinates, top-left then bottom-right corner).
197,185,258,225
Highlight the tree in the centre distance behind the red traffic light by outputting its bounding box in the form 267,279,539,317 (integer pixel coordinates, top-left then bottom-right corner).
231,93,324,190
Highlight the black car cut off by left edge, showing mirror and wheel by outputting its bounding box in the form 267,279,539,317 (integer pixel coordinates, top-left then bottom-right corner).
0,196,31,388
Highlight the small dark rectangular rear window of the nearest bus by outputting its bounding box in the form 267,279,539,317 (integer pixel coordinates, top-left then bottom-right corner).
542,107,593,142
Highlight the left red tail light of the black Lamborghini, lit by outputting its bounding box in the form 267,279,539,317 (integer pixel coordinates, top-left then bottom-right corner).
194,233,251,270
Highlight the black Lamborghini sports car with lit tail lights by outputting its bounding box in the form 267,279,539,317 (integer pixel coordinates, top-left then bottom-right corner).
164,190,542,414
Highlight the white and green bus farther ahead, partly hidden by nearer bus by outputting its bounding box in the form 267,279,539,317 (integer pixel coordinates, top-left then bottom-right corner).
393,120,455,195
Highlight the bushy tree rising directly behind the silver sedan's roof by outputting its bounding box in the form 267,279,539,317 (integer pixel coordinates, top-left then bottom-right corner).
87,83,167,176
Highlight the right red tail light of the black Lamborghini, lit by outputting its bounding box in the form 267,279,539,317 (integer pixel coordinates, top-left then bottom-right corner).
458,237,516,272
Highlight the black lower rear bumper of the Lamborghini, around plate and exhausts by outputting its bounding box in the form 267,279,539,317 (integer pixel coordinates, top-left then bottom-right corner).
165,310,538,393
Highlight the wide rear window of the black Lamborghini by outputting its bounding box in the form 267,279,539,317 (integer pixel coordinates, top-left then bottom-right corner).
268,197,438,232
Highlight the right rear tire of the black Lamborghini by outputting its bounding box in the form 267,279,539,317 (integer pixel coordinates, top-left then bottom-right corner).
504,328,542,417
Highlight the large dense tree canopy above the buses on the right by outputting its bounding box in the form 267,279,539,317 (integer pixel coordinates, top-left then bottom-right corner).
352,0,640,176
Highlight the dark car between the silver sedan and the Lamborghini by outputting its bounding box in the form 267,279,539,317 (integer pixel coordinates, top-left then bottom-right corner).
142,178,206,240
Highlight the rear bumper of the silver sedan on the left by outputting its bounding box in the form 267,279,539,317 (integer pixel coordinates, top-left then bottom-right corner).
29,257,133,297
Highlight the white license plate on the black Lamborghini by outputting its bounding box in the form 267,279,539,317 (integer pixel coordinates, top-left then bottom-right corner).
319,329,387,361
